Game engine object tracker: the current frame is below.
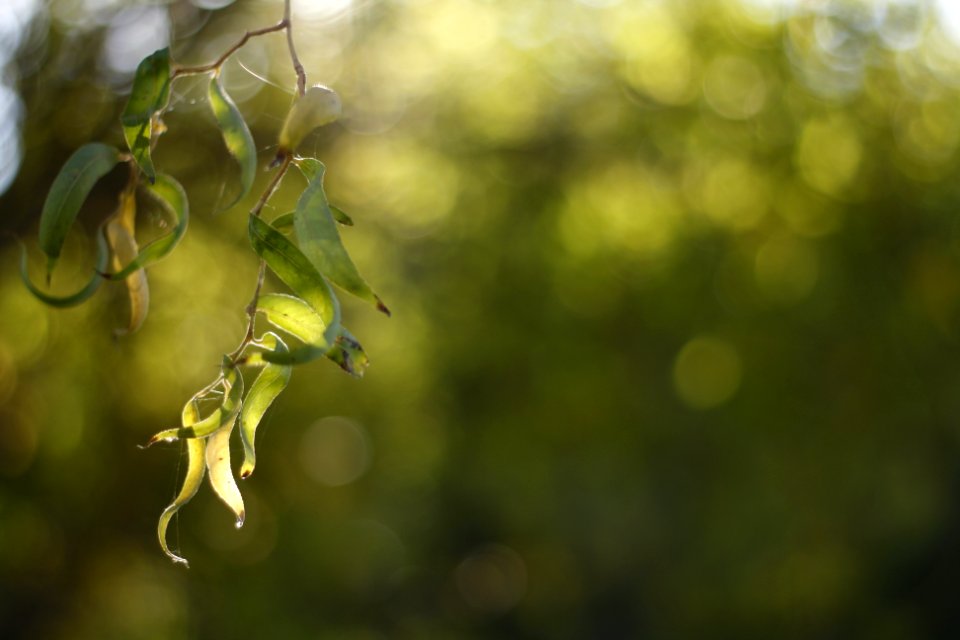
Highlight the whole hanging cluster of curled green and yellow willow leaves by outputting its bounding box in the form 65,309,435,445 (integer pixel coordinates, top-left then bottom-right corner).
21,37,389,564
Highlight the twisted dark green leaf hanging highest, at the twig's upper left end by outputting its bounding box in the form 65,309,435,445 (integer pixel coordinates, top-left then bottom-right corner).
120,48,170,182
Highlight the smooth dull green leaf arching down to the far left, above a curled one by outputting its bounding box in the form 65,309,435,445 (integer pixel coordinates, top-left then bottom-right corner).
40,142,120,284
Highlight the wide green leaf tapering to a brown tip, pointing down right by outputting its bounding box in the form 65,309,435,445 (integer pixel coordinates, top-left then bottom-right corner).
294,160,390,315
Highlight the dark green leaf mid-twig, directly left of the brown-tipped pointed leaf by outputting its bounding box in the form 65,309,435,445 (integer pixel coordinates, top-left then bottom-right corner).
248,216,340,344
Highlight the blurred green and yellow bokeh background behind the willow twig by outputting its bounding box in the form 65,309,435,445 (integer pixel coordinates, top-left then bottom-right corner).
0,0,960,640
